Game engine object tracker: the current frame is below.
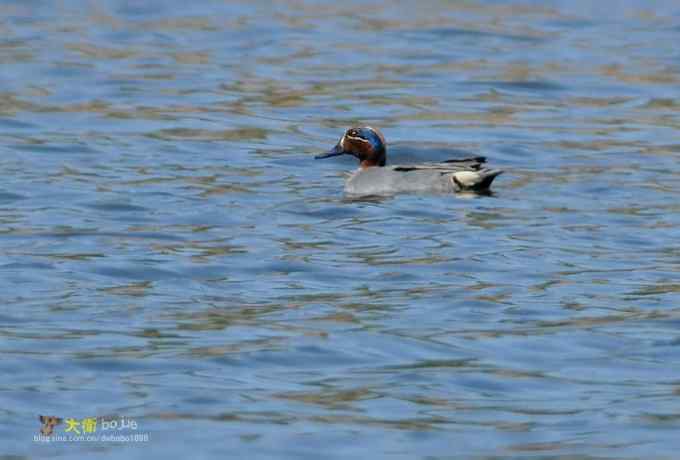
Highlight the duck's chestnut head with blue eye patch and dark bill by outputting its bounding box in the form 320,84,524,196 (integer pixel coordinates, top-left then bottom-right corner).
314,126,387,168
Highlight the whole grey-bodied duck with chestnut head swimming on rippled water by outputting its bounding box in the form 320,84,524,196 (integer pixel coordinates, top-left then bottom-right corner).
314,126,503,195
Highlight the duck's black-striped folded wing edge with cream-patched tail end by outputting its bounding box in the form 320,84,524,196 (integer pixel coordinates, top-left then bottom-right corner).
392,157,503,190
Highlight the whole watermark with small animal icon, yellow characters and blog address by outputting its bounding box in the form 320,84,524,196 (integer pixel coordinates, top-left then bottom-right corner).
33,415,149,442
